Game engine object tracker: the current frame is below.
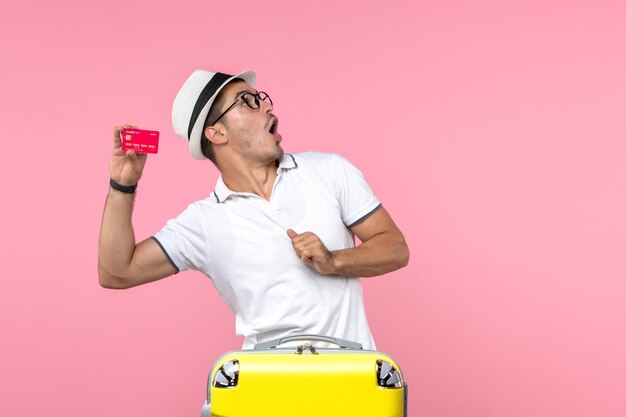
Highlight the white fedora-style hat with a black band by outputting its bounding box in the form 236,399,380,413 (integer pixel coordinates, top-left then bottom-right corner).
172,70,256,159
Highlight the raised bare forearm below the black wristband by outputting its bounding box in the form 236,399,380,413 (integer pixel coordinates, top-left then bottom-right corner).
98,189,135,283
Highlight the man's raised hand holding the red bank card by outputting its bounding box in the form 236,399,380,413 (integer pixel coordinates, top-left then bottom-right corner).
109,124,148,186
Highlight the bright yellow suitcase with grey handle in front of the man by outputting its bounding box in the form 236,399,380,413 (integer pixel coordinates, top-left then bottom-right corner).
202,335,407,417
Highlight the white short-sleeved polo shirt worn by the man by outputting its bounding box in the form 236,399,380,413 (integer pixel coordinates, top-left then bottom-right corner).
153,152,380,349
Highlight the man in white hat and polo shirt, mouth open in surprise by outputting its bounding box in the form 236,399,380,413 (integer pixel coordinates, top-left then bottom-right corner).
98,70,409,349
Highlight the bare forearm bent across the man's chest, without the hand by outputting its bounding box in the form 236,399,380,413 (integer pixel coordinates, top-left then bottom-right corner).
330,232,409,277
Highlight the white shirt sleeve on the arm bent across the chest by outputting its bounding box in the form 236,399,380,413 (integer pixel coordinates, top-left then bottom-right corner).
331,154,381,227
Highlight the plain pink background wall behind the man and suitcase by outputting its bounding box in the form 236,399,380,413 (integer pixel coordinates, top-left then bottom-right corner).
0,0,626,417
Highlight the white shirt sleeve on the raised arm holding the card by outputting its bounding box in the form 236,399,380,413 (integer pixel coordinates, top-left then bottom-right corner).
153,204,210,271
